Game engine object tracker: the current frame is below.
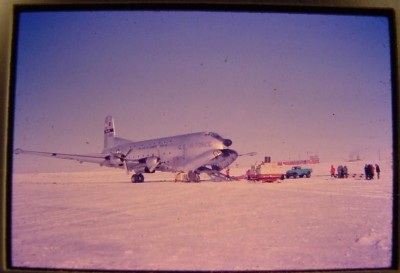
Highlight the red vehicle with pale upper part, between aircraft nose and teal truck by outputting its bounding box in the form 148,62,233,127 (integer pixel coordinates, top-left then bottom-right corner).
246,162,285,182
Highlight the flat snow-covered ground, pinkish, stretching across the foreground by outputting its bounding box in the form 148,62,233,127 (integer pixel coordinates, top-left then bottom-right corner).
12,161,392,270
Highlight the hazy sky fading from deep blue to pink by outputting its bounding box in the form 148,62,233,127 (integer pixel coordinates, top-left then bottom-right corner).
14,11,392,172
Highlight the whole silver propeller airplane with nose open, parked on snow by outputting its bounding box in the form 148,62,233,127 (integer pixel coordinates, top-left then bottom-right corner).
14,115,255,183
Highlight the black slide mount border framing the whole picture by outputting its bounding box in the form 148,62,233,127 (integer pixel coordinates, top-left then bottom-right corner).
0,0,400,272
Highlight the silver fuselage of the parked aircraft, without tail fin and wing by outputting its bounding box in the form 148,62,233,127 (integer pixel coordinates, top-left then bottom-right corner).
104,132,237,173
